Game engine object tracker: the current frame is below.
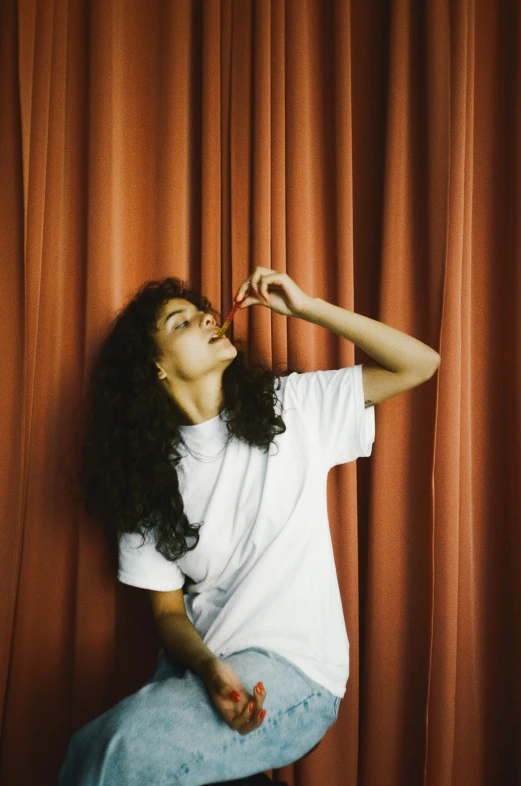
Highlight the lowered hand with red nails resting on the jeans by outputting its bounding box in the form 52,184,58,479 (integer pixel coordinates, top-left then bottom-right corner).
201,658,266,734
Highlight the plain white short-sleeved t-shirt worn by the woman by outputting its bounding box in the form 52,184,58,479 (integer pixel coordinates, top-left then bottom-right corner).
118,364,375,698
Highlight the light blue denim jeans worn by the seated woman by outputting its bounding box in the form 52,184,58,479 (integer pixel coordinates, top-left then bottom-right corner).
58,647,340,786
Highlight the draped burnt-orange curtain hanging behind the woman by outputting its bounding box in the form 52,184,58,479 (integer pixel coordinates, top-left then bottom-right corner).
0,0,521,786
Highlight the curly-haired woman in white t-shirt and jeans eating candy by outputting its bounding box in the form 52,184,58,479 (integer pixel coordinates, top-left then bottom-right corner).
59,267,439,786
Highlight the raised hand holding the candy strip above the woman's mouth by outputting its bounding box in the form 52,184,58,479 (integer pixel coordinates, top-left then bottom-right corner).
235,267,311,317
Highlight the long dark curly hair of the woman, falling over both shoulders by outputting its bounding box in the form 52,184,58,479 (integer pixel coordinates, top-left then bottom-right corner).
76,277,298,561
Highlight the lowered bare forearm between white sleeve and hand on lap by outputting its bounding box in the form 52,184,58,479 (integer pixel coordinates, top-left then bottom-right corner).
156,613,215,679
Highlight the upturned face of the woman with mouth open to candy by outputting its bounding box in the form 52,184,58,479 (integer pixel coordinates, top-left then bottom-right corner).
156,298,237,384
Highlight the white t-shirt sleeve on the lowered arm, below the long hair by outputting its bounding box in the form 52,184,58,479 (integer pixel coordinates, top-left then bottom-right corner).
118,531,185,592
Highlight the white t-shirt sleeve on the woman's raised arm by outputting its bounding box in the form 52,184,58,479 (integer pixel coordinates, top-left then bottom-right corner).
286,364,375,468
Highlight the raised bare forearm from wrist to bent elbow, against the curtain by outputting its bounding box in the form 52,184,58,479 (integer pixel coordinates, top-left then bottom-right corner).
299,298,440,375
